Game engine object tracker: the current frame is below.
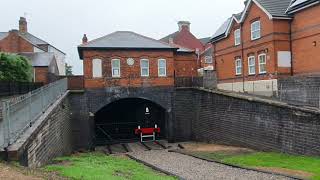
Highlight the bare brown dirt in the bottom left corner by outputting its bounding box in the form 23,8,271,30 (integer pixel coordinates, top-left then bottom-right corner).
0,162,64,180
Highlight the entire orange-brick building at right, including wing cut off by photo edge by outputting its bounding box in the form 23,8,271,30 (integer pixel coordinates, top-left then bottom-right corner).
211,0,320,95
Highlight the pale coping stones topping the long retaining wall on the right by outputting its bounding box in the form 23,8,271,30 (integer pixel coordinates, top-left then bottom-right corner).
177,87,320,114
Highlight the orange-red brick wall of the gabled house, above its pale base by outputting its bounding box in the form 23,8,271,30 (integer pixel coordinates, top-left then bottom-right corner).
215,3,290,83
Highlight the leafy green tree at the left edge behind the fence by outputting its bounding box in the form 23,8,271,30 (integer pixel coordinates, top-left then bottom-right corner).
0,53,32,82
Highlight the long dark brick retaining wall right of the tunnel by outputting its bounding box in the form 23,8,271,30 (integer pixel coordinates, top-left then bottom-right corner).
174,88,320,155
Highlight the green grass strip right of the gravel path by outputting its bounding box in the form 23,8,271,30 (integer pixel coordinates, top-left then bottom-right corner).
193,152,320,180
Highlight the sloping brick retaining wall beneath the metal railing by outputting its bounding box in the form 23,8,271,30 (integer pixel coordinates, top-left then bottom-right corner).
8,92,72,167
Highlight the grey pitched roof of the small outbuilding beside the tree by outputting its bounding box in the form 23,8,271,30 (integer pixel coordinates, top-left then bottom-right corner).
19,52,55,67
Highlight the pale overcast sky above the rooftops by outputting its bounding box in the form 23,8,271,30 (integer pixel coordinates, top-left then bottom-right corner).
0,0,244,74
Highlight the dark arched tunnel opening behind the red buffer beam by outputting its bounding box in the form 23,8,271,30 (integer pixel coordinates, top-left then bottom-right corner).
94,98,166,145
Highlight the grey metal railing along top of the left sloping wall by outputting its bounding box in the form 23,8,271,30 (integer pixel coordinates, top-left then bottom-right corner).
0,78,68,149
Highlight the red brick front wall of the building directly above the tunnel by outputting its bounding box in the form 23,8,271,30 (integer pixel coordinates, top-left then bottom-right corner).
83,50,174,88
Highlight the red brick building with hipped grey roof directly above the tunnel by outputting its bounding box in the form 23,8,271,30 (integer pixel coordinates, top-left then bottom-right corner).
78,31,197,89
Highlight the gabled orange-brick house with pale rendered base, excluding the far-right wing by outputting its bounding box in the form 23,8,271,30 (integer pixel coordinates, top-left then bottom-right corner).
211,0,292,96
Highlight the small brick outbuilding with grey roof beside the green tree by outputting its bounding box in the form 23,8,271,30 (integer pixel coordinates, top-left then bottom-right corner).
19,52,59,84
